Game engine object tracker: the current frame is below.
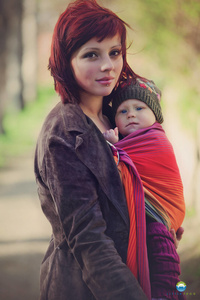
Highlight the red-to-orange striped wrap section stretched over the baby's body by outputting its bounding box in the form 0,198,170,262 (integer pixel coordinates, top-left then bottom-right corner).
115,122,185,231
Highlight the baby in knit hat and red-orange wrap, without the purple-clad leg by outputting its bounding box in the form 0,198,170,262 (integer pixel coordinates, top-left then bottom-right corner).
104,79,185,231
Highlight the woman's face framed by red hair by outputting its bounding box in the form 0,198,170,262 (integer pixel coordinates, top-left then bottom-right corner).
71,34,123,97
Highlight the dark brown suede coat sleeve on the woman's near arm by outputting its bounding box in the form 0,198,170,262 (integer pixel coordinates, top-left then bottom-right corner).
45,137,147,300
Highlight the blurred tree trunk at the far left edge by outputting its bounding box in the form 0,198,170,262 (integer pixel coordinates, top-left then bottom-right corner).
0,0,24,134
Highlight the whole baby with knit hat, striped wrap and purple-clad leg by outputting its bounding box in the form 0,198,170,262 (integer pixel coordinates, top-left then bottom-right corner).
104,79,185,299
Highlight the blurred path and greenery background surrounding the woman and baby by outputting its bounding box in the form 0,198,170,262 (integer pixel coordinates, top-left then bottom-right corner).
0,0,200,300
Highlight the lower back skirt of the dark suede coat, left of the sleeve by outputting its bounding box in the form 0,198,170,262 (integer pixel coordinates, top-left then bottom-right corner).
40,242,95,300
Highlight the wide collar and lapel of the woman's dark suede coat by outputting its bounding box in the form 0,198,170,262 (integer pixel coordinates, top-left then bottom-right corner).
61,104,129,226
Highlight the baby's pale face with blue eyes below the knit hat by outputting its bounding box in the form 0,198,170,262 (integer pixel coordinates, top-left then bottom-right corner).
115,99,156,136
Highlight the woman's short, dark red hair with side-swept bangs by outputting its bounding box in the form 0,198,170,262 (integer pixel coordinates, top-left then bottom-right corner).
48,0,137,103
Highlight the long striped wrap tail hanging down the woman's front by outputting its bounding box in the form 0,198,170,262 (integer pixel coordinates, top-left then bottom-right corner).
112,148,151,299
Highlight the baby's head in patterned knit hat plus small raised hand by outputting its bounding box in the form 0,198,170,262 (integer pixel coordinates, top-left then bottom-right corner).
104,79,163,144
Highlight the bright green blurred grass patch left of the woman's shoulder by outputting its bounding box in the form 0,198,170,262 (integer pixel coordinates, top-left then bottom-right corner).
0,87,55,167
